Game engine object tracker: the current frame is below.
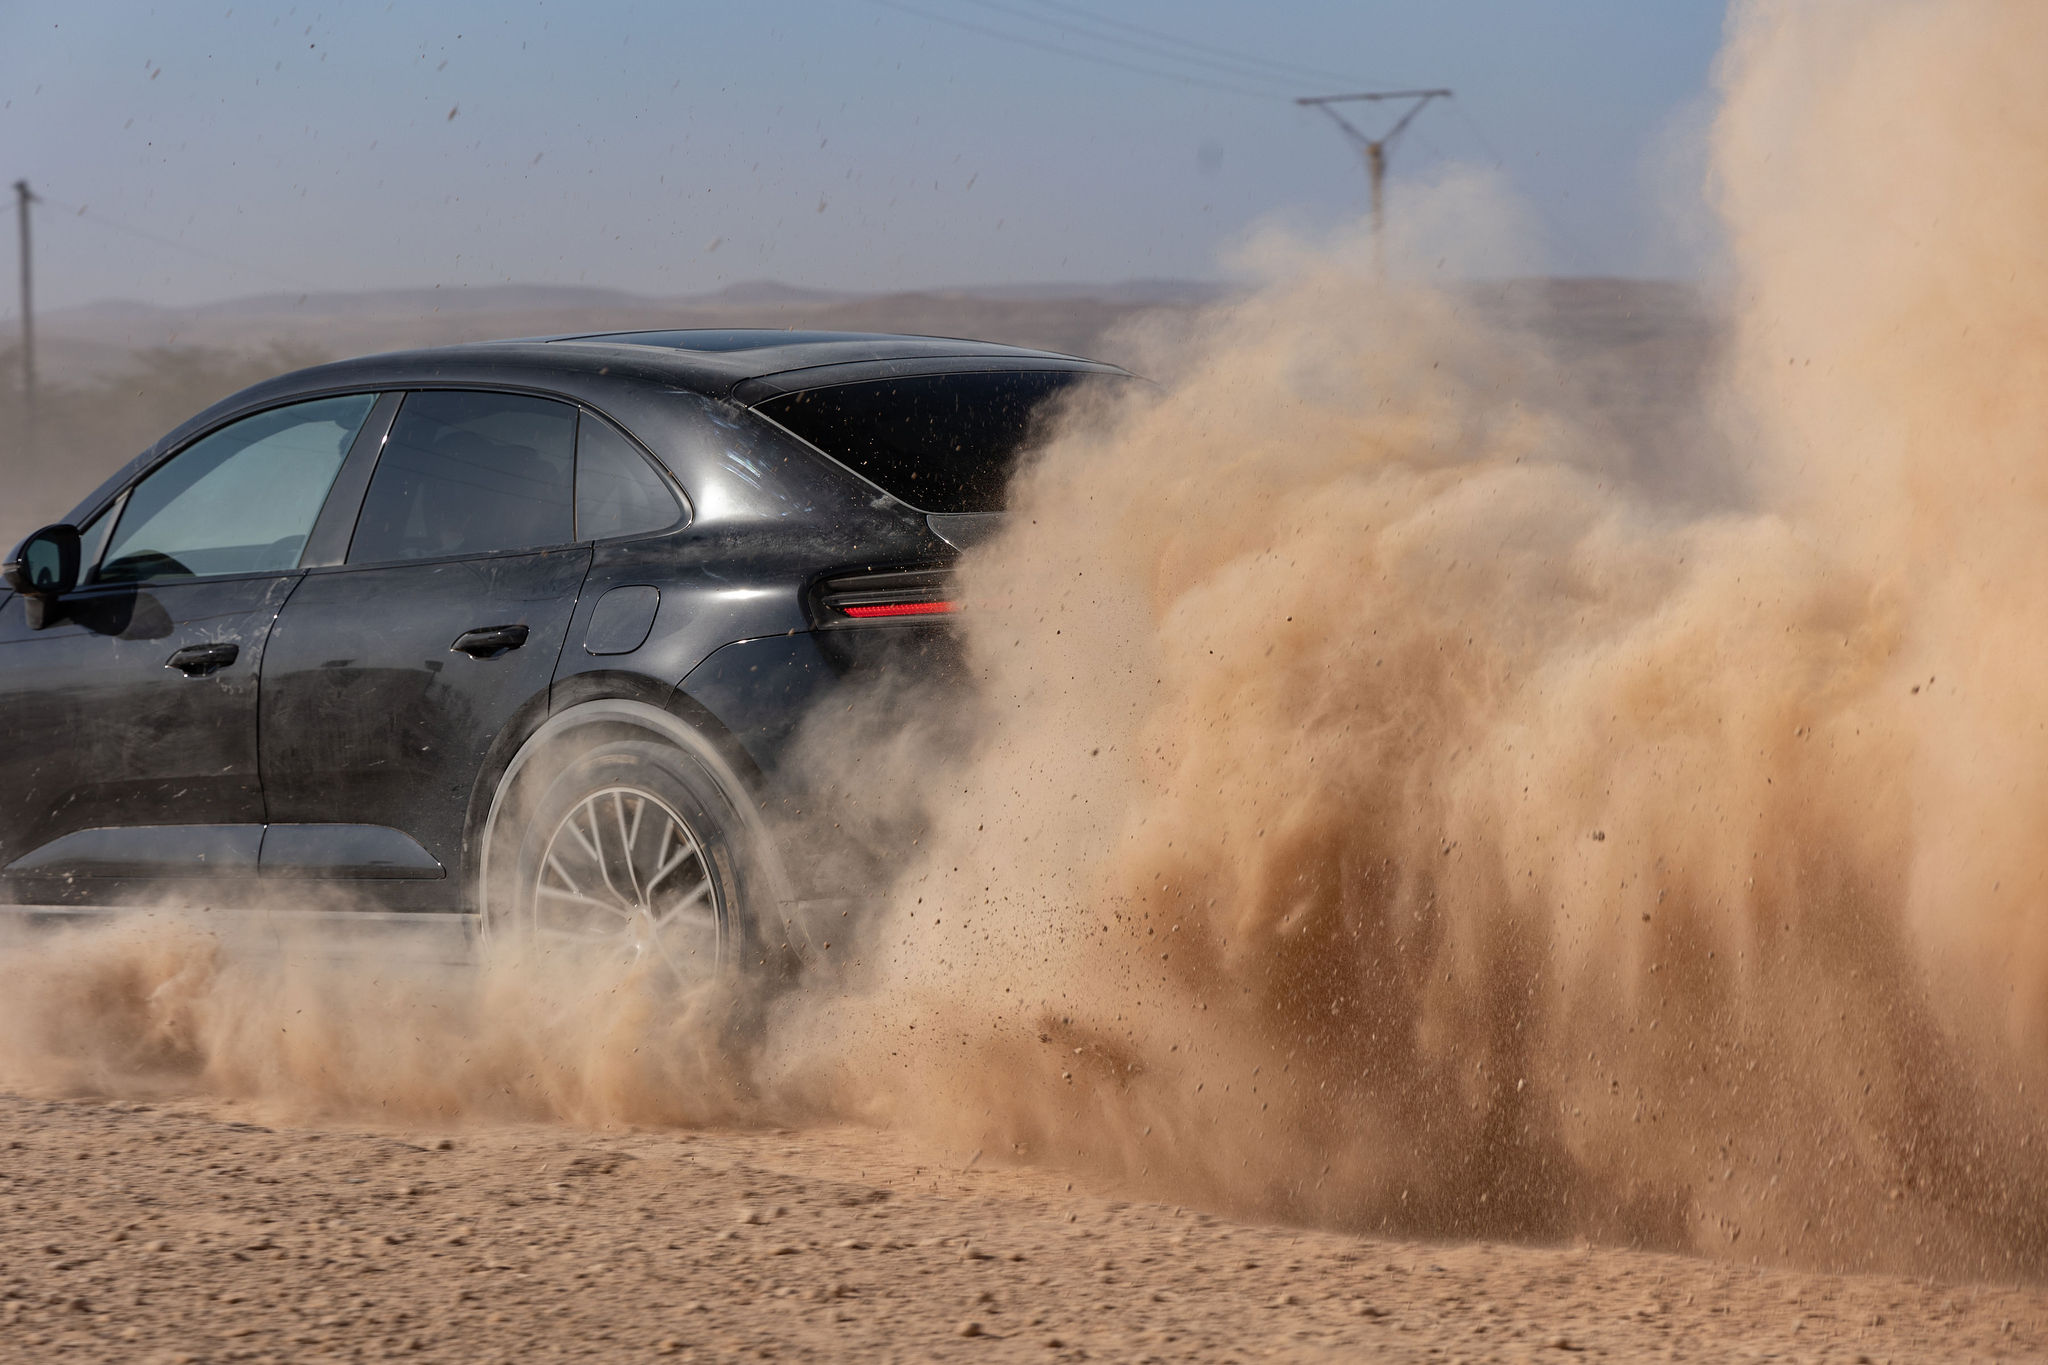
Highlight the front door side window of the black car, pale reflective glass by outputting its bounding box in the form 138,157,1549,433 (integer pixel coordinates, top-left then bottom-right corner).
94,393,377,583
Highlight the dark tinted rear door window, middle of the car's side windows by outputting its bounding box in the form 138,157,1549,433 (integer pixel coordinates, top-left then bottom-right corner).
348,393,575,565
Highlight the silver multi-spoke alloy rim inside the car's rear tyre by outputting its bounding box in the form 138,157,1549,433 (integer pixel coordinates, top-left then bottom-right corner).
532,786,725,980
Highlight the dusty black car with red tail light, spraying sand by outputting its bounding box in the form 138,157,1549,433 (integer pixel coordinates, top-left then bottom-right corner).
0,329,1126,972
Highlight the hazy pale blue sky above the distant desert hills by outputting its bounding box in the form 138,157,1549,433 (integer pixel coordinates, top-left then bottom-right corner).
0,0,1722,313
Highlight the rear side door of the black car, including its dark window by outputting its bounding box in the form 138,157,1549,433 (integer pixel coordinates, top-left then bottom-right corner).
260,389,590,909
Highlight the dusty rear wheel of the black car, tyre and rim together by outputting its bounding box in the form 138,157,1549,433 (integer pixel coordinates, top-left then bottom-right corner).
483,739,750,984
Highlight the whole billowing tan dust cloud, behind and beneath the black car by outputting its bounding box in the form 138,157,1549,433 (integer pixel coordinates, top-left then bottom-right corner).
0,0,2048,1277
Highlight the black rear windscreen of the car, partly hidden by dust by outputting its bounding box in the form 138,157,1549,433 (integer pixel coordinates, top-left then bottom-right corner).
758,370,1104,512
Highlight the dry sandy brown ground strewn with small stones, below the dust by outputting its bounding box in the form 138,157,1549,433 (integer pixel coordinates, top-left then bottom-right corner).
0,1097,2048,1363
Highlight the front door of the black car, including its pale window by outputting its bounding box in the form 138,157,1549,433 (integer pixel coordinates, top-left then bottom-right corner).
0,395,377,902
